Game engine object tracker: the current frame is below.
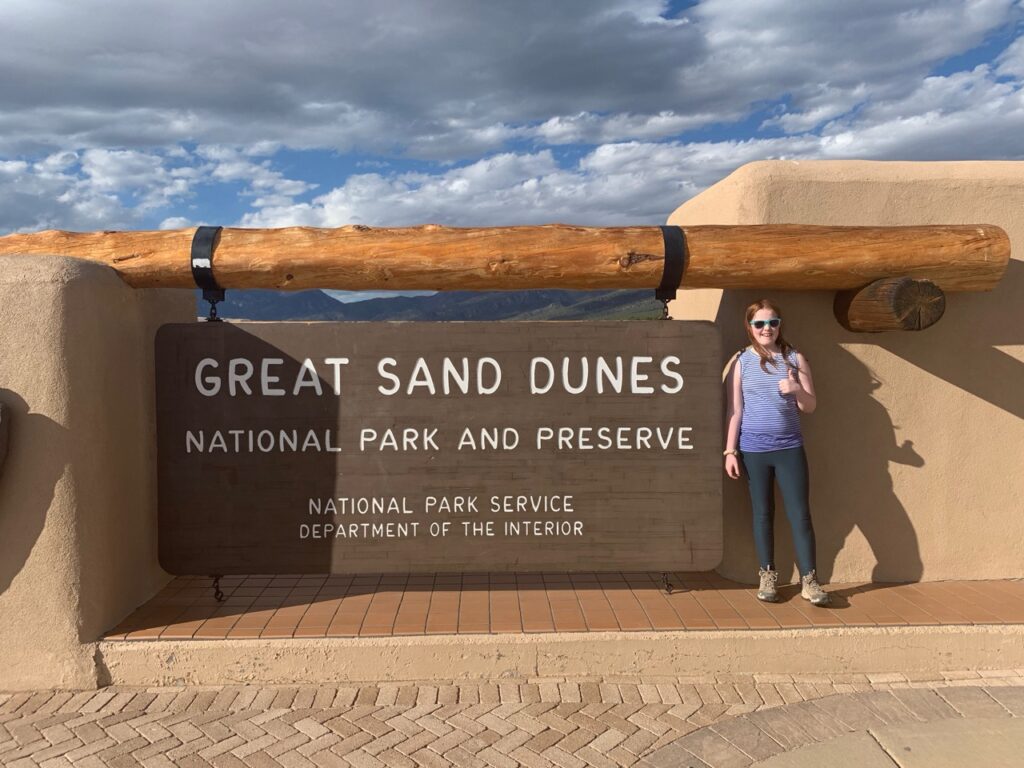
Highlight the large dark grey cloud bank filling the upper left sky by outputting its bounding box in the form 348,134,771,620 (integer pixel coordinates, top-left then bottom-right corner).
0,0,701,158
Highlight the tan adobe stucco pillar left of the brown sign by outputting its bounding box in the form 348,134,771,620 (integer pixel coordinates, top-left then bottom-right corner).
0,256,195,689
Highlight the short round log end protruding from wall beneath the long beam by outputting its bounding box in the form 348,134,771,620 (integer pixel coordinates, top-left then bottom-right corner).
833,278,946,333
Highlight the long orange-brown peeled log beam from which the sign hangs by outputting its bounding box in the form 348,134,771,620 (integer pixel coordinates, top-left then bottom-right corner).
0,224,1010,291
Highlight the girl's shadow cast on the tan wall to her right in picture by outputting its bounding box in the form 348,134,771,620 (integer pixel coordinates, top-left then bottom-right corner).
798,345,925,582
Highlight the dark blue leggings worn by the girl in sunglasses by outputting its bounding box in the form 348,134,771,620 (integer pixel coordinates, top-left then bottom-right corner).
742,446,815,575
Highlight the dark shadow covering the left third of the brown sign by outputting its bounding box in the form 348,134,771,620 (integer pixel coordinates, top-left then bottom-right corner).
157,323,340,575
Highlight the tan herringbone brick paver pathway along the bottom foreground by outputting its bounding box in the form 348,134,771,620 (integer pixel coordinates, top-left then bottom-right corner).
0,670,1024,768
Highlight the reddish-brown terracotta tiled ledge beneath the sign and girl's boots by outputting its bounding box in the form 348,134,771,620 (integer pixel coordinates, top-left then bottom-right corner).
106,573,1024,640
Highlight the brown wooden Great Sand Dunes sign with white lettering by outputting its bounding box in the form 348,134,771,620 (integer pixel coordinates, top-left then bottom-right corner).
156,321,722,574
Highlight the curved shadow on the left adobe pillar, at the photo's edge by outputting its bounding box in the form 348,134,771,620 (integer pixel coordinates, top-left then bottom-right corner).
0,389,68,595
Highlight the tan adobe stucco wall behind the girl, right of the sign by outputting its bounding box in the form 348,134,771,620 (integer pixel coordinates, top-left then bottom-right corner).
669,161,1024,582
